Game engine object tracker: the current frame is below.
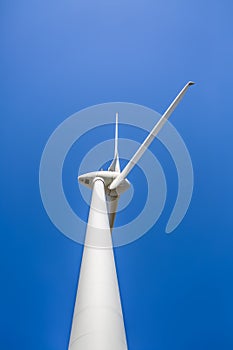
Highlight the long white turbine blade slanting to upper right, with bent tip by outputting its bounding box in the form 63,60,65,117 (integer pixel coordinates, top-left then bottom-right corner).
109,81,194,190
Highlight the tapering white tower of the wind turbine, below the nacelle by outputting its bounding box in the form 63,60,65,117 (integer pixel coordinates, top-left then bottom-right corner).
69,178,127,350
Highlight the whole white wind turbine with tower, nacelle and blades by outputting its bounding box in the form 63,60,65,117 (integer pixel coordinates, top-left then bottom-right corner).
69,82,194,350
